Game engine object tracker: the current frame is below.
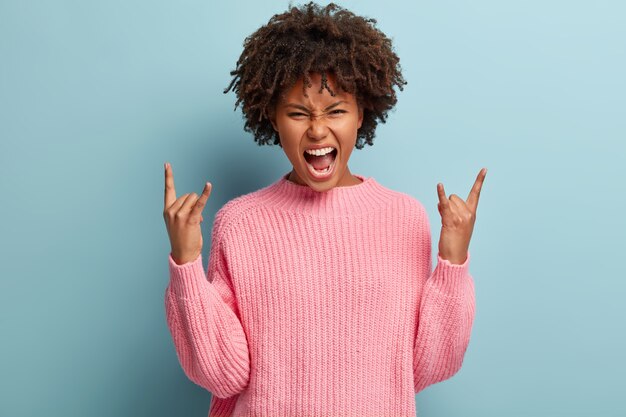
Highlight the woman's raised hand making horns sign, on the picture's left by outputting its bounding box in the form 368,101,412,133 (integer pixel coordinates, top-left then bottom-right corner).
163,162,213,265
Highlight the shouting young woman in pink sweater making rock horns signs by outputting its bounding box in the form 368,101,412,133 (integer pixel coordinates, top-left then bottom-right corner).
163,3,486,417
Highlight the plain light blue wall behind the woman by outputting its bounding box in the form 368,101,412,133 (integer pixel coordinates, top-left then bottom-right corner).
0,0,626,417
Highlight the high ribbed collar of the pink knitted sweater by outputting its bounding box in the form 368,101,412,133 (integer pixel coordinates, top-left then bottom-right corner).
258,173,393,217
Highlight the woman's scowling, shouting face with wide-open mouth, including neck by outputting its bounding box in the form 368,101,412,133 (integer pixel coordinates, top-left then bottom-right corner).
271,73,363,191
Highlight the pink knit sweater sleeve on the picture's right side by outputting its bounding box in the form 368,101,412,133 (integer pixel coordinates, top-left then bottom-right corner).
413,207,475,393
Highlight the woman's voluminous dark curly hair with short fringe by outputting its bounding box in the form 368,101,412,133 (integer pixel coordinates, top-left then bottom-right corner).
224,2,407,149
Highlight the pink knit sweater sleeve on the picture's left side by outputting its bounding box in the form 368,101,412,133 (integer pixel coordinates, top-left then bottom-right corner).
165,212,250,398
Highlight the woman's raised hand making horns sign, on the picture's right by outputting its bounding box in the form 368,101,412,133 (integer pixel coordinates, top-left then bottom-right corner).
437,168,487,265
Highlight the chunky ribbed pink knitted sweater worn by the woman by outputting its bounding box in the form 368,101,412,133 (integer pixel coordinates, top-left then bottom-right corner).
165,174,475,417
